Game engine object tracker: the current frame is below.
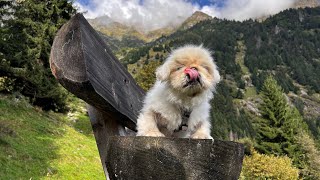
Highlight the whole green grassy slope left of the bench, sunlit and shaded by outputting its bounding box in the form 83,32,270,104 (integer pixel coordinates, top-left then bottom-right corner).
0,96,105,179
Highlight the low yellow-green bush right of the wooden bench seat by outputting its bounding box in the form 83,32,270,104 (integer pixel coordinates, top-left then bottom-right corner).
240,150,299,180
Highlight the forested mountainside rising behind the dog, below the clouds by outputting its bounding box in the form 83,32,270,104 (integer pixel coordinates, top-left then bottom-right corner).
120,7,320,144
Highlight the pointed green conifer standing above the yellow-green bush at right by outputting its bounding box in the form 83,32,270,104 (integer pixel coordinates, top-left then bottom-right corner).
256,76,305,162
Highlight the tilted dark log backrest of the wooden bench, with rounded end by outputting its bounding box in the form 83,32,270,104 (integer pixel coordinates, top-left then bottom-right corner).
50,14,144,130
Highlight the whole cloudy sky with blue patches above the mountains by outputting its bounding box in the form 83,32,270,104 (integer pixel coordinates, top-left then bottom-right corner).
75,0,296,31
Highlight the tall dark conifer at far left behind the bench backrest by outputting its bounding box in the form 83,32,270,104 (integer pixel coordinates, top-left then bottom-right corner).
0,0,76,110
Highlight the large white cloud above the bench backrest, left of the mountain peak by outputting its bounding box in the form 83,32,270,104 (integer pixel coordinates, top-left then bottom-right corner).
75,0,199,31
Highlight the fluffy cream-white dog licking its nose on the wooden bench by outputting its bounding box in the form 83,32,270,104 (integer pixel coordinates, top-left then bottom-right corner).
137,45,220,139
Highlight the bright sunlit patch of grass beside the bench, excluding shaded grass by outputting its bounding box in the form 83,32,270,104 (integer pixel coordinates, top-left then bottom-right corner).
48,124,105,179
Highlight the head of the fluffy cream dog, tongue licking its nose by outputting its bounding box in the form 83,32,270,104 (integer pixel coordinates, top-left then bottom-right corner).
156,46,220,94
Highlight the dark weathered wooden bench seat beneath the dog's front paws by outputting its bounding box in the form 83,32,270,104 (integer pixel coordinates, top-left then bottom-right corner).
106,136,244,180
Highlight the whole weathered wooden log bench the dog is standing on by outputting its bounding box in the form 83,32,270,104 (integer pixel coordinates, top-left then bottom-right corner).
50,14,244,180
